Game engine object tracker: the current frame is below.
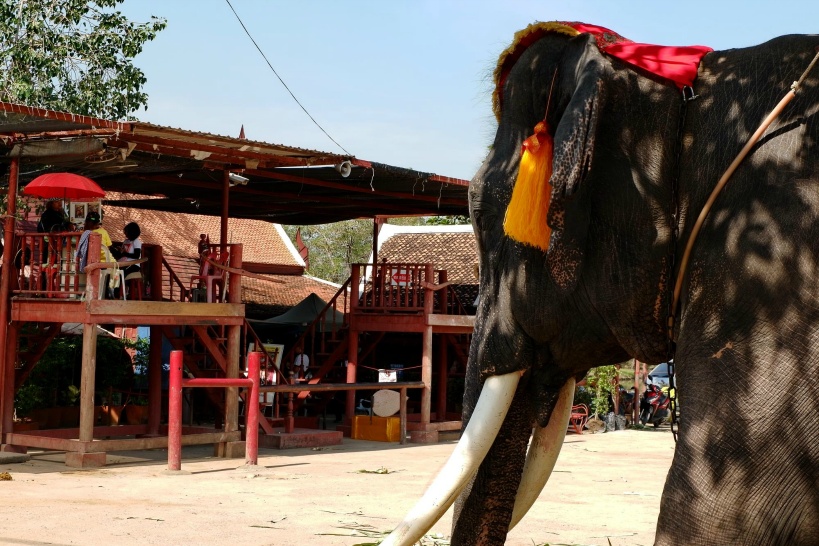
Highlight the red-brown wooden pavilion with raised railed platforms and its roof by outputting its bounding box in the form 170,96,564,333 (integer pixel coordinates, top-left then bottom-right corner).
0,102,474,467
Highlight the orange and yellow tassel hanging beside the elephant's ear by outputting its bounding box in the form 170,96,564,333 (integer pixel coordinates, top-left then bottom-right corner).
503,121,554,252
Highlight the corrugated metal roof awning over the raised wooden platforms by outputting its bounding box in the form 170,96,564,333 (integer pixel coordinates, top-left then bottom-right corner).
0,102,468,224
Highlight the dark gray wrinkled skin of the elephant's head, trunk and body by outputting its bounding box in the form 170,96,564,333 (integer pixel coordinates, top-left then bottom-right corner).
462,35,819,545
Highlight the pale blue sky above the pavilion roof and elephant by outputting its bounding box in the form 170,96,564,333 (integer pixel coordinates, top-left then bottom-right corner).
120,0,819,179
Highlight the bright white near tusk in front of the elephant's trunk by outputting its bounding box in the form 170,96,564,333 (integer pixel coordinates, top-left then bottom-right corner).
381,372,521,546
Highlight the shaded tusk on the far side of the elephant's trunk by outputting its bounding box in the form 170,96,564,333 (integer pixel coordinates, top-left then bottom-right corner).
509,377,574,530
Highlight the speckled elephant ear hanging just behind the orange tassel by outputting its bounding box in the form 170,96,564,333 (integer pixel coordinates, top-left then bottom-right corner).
546,38,605,290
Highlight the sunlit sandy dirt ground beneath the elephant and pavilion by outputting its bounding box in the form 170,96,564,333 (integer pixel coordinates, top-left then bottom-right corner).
0,429,674,546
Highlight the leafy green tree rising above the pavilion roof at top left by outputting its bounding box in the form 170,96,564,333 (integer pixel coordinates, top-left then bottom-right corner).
0,0,166,119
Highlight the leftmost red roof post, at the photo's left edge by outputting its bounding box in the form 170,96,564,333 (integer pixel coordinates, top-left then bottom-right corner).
0,157,20,442
